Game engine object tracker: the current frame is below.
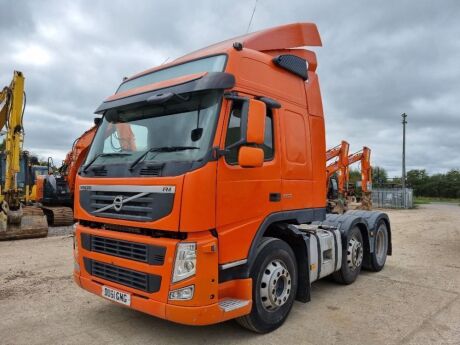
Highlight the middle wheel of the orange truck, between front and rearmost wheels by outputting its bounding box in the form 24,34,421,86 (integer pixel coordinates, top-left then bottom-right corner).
332,226,364,285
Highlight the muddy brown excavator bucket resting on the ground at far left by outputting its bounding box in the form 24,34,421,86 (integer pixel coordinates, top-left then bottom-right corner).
0,206,48,241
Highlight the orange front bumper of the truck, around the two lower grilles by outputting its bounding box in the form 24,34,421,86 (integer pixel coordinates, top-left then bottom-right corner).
74,225,252,325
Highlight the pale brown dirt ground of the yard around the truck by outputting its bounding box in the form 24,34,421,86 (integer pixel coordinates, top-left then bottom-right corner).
0,204,460,345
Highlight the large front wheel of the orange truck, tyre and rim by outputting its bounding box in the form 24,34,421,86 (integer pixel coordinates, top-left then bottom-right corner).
236,237,297,333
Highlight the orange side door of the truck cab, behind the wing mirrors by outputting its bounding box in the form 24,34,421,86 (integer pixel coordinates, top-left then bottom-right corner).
216,100,281,263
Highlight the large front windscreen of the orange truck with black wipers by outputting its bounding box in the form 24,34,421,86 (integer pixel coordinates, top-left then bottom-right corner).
85,90,222,166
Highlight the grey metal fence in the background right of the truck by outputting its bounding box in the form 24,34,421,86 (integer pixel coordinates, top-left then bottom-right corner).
372,188,414,208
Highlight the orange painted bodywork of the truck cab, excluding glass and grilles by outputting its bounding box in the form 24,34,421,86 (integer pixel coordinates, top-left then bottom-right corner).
75,23,332,325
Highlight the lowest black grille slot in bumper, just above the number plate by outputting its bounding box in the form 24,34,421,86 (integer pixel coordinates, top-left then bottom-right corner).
83,258,161,293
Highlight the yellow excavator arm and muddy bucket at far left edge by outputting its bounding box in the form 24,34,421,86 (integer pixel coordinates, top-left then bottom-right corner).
0,71,48,240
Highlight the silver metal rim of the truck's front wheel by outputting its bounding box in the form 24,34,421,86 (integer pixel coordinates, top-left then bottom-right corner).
260,260,291,311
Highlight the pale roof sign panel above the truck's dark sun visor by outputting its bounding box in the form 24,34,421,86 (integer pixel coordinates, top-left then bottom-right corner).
117,55,227,93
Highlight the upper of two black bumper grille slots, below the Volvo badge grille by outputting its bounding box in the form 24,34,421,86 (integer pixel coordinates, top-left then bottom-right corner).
81,233,166,265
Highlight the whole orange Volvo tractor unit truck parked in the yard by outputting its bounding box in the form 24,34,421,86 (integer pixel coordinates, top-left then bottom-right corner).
74,23,392,333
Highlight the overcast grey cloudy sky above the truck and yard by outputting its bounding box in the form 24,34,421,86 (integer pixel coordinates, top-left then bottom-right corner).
0,0,460,176
